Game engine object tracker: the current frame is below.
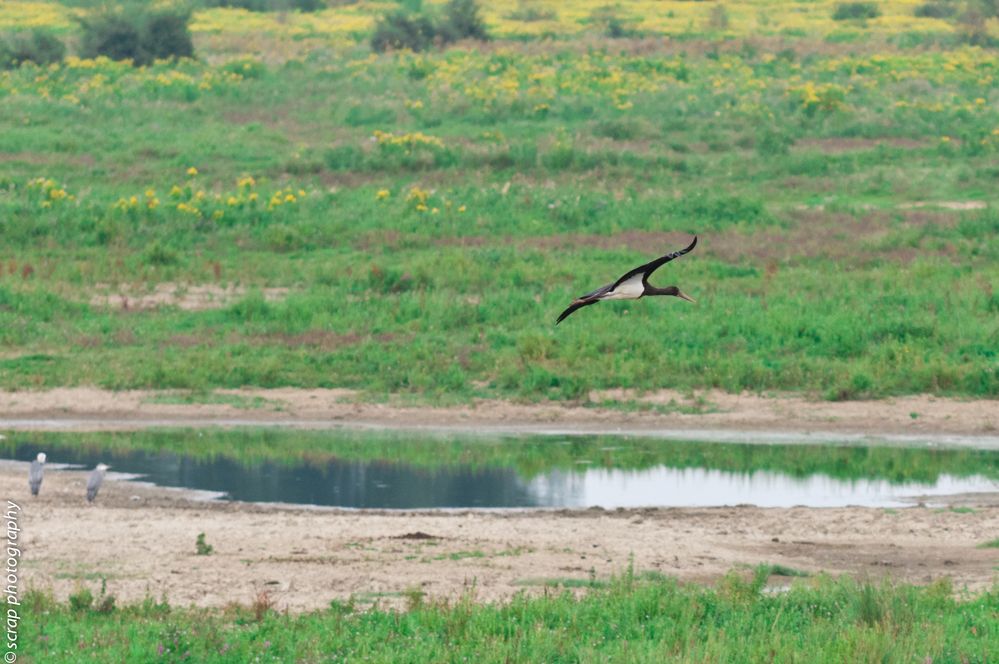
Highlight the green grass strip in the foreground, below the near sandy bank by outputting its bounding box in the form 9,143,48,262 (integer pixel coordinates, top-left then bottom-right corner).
20,573,999,662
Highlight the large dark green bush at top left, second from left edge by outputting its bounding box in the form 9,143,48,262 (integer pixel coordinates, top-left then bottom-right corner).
80,5,194,66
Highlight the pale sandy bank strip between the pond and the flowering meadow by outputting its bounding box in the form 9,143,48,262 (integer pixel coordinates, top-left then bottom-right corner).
0,387,999,447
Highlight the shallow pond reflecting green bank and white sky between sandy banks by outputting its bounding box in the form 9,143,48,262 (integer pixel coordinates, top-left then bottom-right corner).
2,432,999,508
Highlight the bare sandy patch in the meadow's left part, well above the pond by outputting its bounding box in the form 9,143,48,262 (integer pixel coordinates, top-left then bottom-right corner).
90,282,290,311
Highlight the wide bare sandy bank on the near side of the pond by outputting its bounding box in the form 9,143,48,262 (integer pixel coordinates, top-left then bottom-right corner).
9,462,999,611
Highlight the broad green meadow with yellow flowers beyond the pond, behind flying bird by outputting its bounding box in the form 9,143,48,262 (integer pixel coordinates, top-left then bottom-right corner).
0,3,999,402
